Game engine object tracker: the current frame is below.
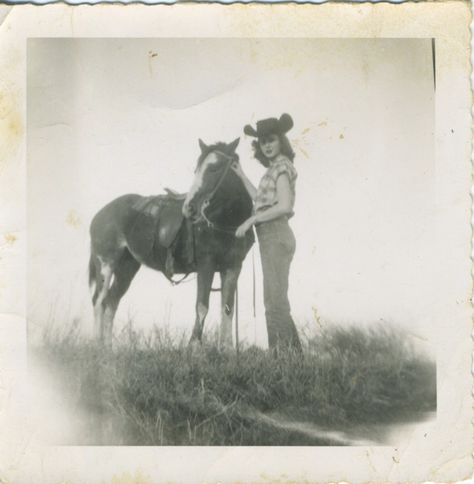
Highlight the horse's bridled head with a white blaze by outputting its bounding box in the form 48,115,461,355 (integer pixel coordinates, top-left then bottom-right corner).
183,138,240,219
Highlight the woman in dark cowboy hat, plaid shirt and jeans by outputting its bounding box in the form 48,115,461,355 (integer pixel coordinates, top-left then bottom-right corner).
233,114,301,352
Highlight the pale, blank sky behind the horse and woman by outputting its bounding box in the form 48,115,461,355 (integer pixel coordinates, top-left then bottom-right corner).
27,38,434,346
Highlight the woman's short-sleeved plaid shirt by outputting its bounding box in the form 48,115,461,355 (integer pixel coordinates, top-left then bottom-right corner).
254,155,298,217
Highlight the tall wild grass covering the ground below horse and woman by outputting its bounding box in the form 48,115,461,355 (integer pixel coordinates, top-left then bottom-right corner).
33,325,436,445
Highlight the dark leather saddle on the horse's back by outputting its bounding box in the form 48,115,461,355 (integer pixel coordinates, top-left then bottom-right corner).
132,188,194,280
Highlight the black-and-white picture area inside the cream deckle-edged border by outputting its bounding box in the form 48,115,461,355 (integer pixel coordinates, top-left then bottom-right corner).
26,38,439,447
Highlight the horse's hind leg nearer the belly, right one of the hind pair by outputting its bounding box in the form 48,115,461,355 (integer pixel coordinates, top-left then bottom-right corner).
103,251,140,346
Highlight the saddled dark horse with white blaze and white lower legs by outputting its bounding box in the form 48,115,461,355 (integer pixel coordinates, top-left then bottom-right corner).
89,138,255,348
